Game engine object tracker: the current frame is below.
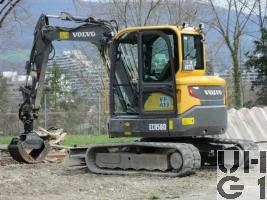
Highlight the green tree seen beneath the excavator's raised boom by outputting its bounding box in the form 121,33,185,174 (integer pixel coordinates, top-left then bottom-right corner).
42,62,83,111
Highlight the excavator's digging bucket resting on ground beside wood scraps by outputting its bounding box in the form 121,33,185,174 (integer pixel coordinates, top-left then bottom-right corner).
8,132,50,164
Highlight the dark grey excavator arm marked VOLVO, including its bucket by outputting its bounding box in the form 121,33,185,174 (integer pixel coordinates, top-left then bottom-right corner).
9,12,117,163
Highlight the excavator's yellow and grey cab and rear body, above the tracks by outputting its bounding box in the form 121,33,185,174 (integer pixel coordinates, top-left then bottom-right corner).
109,26,227,138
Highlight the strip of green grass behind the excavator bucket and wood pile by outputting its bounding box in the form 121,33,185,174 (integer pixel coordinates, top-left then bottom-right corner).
0,135,138,146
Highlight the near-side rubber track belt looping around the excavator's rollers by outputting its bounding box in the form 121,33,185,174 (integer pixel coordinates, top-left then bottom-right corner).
85,142,201,177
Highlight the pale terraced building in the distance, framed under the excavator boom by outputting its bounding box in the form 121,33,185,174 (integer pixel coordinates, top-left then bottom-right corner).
48,50,104,106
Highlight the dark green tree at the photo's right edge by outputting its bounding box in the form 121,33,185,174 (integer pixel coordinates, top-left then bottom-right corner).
245,28,267,105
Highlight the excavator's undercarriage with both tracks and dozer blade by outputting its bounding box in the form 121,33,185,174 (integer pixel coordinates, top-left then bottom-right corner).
69,137,257,176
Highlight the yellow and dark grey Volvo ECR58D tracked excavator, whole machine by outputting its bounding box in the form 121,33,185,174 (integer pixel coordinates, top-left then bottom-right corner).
8,12,255,176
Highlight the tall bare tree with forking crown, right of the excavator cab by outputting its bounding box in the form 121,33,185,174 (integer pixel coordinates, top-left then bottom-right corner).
209,0,258,108
